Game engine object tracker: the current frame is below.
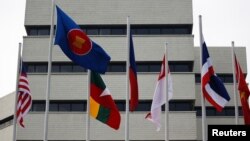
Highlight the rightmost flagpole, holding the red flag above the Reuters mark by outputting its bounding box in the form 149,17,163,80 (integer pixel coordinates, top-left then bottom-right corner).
232,41,239,125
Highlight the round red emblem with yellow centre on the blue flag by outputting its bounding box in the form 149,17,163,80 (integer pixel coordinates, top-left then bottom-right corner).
68,29,92,56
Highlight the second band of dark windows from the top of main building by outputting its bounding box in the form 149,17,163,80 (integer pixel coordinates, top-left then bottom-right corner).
27,61,193,73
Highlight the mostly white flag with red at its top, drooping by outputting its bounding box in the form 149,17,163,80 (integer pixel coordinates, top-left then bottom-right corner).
146,56,173,131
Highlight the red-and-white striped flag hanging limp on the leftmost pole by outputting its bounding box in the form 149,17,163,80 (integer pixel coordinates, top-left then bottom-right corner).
16,63,32,128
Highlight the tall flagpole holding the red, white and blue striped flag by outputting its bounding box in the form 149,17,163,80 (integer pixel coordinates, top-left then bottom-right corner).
199,15,207,141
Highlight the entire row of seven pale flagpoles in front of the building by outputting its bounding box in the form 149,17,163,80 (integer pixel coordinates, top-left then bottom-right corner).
13,0,246,141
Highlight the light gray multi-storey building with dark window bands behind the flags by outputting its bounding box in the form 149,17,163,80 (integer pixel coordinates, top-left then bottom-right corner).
0,0,247,141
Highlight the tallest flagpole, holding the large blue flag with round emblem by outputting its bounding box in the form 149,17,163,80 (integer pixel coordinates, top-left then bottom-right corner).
44,0,55,141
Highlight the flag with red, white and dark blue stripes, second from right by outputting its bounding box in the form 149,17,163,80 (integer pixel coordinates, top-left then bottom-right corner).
201,36,230,111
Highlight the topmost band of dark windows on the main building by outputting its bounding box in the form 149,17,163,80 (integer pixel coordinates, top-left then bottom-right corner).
26,25,192,36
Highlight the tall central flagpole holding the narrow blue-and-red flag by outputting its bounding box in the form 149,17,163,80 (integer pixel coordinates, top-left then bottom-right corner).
125,16,130,141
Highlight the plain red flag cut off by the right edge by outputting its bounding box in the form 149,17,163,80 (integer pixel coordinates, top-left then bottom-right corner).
234,54,250,125
